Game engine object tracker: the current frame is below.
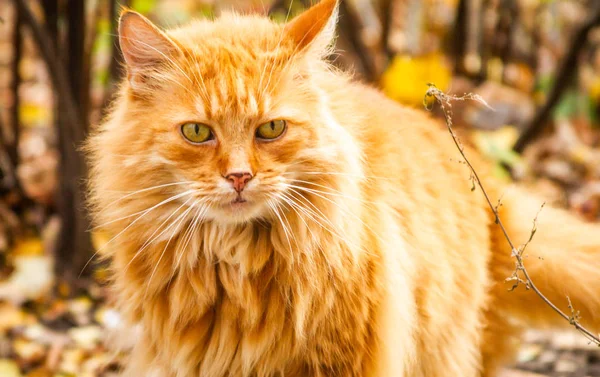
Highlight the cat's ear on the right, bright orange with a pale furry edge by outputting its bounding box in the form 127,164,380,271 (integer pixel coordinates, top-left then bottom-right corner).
285,0,338,54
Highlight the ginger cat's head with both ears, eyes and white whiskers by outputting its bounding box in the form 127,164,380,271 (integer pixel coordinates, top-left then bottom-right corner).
88,0,360,228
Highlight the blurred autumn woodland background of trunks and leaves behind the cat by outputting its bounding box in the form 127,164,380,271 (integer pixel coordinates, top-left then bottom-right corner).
0,0,600,377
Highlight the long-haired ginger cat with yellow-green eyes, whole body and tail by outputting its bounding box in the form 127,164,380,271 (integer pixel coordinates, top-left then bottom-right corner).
87,0,600,377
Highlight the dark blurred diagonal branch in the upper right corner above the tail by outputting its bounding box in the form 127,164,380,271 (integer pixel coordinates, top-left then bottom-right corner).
514,1,600,153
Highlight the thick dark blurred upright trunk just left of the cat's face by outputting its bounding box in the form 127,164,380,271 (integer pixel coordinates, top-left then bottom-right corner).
38,0,92,280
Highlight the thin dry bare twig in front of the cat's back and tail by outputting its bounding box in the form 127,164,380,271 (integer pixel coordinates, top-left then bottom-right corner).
423,84,600,346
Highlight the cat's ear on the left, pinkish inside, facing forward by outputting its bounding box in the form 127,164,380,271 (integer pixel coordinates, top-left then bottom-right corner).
119,10,179,88
